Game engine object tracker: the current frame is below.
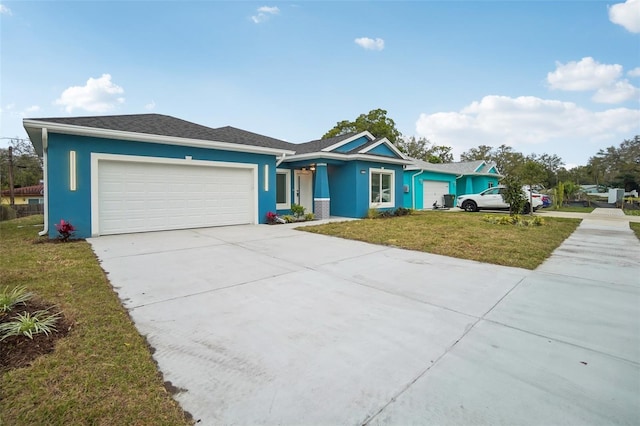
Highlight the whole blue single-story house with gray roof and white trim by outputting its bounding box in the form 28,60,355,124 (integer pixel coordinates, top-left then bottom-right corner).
23,114,409,238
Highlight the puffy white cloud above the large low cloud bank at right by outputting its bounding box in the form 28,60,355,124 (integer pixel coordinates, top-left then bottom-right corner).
547,57,622,91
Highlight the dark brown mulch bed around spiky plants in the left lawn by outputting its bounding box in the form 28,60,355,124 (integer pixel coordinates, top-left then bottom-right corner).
0,300,73,372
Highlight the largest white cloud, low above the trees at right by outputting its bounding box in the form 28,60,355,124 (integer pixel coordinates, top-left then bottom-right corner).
416,95,640,155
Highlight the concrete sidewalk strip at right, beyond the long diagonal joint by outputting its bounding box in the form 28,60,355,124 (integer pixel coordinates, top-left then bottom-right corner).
371,209,640,425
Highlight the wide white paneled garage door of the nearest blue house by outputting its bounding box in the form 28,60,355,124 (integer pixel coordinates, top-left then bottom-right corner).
94,161,256,235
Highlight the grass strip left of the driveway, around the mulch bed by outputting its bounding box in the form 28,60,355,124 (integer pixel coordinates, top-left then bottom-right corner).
0,216,191,425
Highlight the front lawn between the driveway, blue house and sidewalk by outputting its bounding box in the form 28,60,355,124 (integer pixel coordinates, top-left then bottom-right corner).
298,212,580,269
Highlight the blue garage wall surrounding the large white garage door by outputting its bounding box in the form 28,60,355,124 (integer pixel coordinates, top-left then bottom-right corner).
47,133,276,238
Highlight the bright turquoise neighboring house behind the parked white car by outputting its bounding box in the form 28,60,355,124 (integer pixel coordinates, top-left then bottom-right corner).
404,159,502,210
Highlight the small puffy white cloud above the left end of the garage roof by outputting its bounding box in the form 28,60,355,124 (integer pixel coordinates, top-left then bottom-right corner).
55,74,124,113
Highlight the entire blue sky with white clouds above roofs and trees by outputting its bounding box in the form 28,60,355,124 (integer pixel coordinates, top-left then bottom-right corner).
0,0,640,166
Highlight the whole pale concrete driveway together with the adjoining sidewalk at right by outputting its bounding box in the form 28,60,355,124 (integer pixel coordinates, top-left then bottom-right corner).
90,212,640,425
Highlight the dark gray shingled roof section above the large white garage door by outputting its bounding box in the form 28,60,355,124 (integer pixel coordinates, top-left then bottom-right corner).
30,114,296,150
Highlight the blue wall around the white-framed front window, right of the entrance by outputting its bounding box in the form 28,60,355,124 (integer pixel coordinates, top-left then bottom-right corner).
328,161,403,217
